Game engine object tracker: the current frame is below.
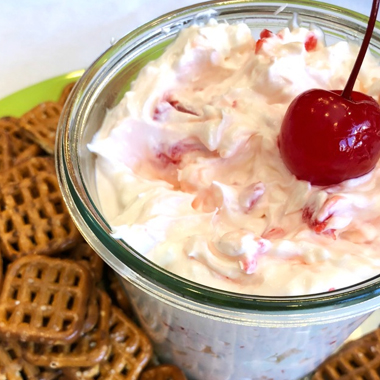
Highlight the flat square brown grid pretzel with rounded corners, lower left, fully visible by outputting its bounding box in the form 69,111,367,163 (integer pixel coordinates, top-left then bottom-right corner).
0,256,92,344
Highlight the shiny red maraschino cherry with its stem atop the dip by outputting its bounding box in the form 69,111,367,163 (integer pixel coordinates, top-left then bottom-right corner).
278,0,380,186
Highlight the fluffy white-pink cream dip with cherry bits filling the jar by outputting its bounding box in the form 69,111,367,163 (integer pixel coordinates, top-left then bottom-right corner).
89,20,380,296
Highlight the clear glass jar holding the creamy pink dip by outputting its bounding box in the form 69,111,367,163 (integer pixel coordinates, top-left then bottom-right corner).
56,0,380,380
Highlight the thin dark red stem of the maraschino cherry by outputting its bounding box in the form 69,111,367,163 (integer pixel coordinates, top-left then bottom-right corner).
341,0,380,100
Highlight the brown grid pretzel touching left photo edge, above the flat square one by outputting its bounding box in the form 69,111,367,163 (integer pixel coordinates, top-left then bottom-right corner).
0,157,82,260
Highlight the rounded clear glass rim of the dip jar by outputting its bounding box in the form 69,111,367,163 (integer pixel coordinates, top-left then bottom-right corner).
56,0,380,311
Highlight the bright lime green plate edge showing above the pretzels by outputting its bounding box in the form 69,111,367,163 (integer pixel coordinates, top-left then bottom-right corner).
0,70,84,117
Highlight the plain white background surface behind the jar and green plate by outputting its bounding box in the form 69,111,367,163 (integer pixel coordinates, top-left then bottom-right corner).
0,0,372,99
